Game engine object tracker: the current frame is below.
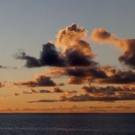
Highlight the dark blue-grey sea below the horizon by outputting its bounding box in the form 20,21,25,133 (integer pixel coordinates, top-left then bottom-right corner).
0,114,135,135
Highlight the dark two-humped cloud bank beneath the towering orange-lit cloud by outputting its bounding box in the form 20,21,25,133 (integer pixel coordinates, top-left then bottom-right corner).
15,43,95,68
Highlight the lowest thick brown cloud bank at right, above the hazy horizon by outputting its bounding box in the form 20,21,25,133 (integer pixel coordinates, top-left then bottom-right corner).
59,86,135,102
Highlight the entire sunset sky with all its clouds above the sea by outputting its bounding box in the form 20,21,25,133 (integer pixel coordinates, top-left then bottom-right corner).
0,0,135,113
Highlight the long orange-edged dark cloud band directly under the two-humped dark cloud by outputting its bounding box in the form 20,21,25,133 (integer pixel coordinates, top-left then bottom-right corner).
49,66,135,85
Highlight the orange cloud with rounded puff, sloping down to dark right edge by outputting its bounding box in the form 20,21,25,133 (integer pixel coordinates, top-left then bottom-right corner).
91,28,135,69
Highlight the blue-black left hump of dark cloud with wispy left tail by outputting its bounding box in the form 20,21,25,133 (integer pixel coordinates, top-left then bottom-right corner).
15,42,64,68
